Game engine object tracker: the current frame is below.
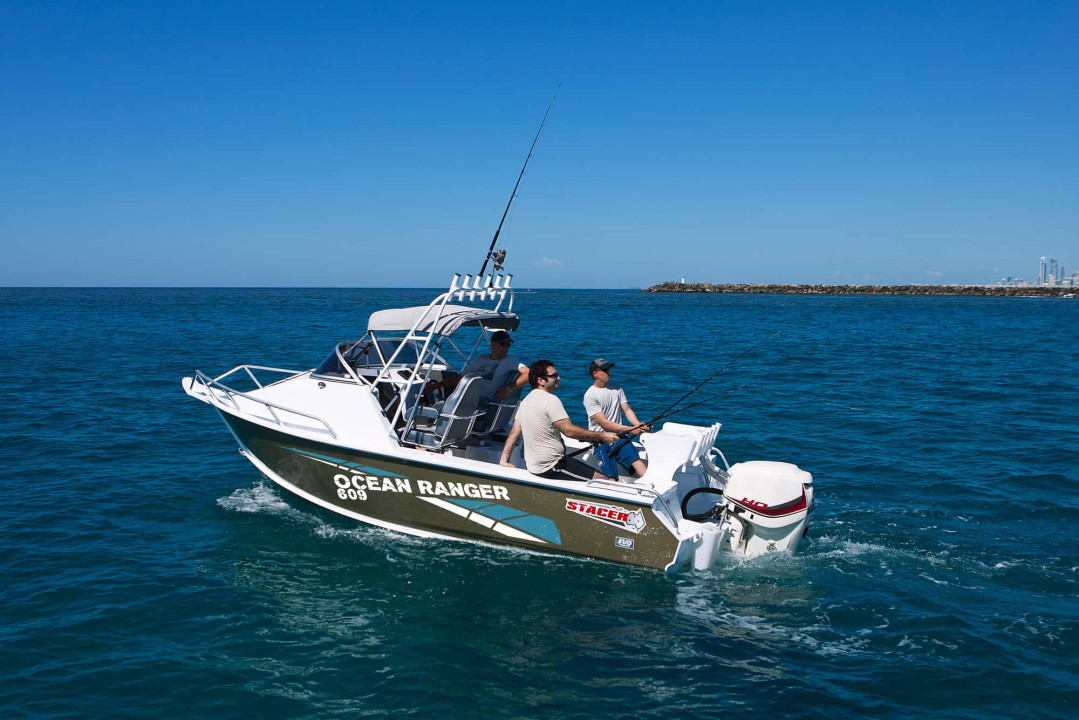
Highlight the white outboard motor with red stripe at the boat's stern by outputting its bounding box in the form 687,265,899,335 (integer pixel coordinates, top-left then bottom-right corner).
723,461,812,556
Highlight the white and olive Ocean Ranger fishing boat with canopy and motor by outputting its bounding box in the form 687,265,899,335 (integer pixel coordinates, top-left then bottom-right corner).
182,273,814,571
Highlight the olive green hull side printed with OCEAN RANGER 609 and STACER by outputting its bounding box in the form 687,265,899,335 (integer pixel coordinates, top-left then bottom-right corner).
221,412,679,570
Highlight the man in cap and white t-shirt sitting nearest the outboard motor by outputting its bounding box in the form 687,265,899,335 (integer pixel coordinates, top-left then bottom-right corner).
585,357,652,477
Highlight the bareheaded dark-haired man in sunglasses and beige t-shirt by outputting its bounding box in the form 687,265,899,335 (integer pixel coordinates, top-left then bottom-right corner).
501,361,618,481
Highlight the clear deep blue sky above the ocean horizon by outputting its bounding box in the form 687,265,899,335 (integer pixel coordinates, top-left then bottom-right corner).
0,0,1079,288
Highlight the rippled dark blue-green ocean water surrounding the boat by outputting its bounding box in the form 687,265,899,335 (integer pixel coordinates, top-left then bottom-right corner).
0,289,1079,719
